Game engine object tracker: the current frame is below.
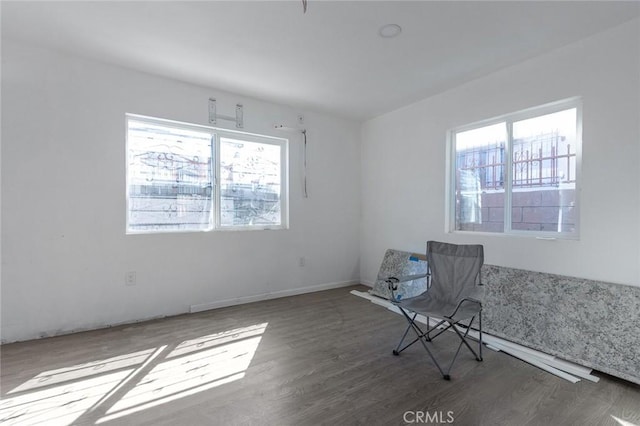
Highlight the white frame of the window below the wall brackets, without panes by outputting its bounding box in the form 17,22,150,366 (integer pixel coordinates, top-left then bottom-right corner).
125,113,289,235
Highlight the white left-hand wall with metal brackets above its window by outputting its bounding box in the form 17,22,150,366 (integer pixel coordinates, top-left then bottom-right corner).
2,40,360,342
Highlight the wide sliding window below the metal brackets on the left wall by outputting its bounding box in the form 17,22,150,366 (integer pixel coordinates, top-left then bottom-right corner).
127,115,288,233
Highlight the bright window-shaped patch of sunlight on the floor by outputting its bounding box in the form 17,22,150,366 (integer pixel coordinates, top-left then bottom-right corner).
0,323,268,425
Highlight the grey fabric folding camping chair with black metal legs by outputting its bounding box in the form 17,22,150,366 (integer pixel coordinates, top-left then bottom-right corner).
386,241,484,380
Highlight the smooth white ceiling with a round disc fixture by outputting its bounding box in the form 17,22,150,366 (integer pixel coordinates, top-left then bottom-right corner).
1,0,640,120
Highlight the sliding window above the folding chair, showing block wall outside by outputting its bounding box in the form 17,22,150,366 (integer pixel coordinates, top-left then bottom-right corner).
449,99,581,238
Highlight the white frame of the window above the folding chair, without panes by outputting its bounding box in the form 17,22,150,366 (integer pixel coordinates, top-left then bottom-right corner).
445,96,583,240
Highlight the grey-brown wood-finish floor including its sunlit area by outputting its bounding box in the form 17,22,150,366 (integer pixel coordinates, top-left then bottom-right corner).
0,286,640,426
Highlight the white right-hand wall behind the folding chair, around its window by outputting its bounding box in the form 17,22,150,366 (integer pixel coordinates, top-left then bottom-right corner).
360,19,640,285
